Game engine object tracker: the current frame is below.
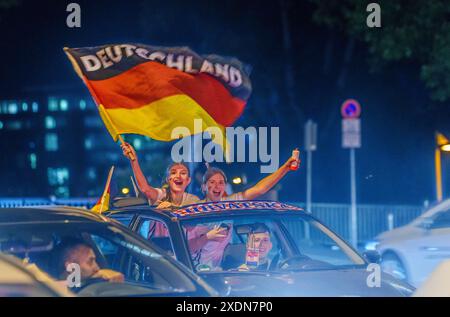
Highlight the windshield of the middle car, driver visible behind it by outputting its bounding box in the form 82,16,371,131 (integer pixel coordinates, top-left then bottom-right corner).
182,212,365,272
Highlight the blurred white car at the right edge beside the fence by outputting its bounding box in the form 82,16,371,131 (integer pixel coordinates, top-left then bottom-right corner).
366,199,450,287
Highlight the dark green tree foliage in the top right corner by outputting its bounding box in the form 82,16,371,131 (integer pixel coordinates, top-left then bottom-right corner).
310,0,450,102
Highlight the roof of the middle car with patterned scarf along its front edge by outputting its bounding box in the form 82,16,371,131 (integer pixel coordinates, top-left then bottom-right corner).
109,200,306,219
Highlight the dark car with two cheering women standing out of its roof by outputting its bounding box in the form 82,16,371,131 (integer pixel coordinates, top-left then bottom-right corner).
107,200,413,296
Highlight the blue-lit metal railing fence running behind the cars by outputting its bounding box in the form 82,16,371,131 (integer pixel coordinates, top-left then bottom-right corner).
0,198,424,244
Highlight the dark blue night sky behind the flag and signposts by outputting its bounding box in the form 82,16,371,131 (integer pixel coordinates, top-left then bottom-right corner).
0,0,450,205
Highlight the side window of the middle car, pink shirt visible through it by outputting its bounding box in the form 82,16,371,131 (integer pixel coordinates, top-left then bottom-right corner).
139,219,175,256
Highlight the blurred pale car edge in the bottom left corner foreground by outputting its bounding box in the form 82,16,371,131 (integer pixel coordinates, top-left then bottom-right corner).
0,253,72,297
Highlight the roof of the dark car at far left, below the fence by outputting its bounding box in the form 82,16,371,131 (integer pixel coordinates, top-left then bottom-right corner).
0,206,108,225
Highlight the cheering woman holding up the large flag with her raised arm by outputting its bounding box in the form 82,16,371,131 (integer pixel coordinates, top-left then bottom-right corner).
121,142,199,208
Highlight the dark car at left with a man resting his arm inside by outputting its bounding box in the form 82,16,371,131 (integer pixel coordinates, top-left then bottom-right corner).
0,207,217,296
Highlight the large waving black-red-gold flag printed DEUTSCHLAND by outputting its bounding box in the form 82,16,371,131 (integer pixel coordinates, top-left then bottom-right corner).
64,44,251,153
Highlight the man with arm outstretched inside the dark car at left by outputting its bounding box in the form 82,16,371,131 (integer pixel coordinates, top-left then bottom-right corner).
55,239,124,284
